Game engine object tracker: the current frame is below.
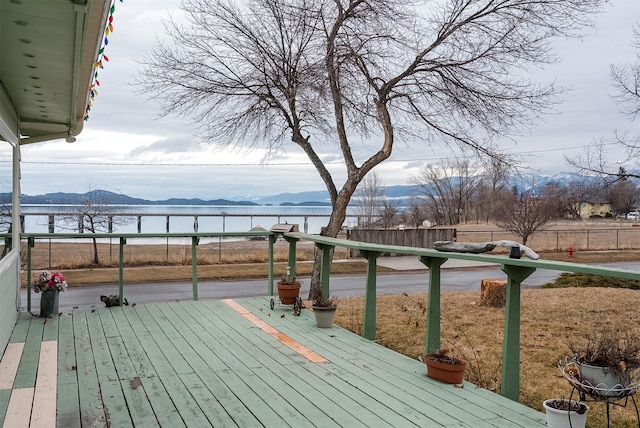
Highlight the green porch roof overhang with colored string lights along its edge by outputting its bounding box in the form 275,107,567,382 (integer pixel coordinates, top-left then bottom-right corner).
0,0,111,145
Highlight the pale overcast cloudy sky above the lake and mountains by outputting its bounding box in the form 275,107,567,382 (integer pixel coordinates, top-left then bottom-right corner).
17,0,640,199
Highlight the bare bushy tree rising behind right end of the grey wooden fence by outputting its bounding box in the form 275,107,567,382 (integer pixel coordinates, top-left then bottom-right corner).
414,159,482,225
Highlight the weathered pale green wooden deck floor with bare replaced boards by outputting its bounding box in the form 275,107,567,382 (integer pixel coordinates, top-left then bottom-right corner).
0,298,546,428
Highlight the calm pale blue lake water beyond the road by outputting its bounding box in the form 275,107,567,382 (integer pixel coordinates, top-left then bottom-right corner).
22,205,356,234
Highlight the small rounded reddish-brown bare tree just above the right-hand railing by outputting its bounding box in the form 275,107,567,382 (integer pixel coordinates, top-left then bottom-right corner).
496,192,553,245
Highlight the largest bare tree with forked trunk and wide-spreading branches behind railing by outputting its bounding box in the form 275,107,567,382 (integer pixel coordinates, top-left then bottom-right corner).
139,0,605,294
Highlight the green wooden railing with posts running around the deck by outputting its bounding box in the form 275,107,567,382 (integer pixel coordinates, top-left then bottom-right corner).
17,232,640,401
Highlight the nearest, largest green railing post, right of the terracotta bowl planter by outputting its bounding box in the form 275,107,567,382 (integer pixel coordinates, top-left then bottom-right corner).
500,264,536,401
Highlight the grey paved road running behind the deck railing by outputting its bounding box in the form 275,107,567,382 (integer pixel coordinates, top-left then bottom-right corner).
22,262,640,310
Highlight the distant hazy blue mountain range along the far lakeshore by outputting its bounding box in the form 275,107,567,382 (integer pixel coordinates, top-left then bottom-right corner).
6,173,596,206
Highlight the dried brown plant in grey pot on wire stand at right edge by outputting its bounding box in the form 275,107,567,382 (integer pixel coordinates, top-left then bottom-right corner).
569,330,640,396
